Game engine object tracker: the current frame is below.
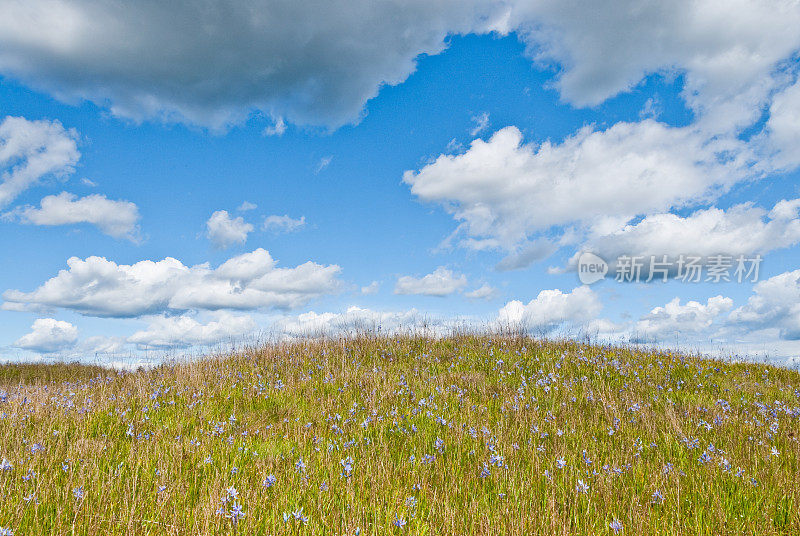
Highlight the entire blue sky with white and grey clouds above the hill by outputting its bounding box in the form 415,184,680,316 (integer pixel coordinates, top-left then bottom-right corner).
0,0,800,363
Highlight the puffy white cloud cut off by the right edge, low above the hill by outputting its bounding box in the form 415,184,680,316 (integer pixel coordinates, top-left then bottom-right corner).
730,270,800,340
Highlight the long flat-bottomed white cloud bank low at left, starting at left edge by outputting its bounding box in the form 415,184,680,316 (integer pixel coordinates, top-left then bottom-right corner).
3,249,340,317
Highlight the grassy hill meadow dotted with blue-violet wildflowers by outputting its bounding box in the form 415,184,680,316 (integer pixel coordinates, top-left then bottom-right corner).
0,336,800,536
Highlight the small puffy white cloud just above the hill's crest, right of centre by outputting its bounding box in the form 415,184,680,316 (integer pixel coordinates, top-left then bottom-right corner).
497,286,602,331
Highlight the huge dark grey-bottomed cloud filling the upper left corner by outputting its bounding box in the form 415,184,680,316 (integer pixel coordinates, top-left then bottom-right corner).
0,0,506,129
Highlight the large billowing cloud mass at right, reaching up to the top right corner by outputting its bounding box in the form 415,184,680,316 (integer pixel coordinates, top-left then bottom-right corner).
396,0,800,270
